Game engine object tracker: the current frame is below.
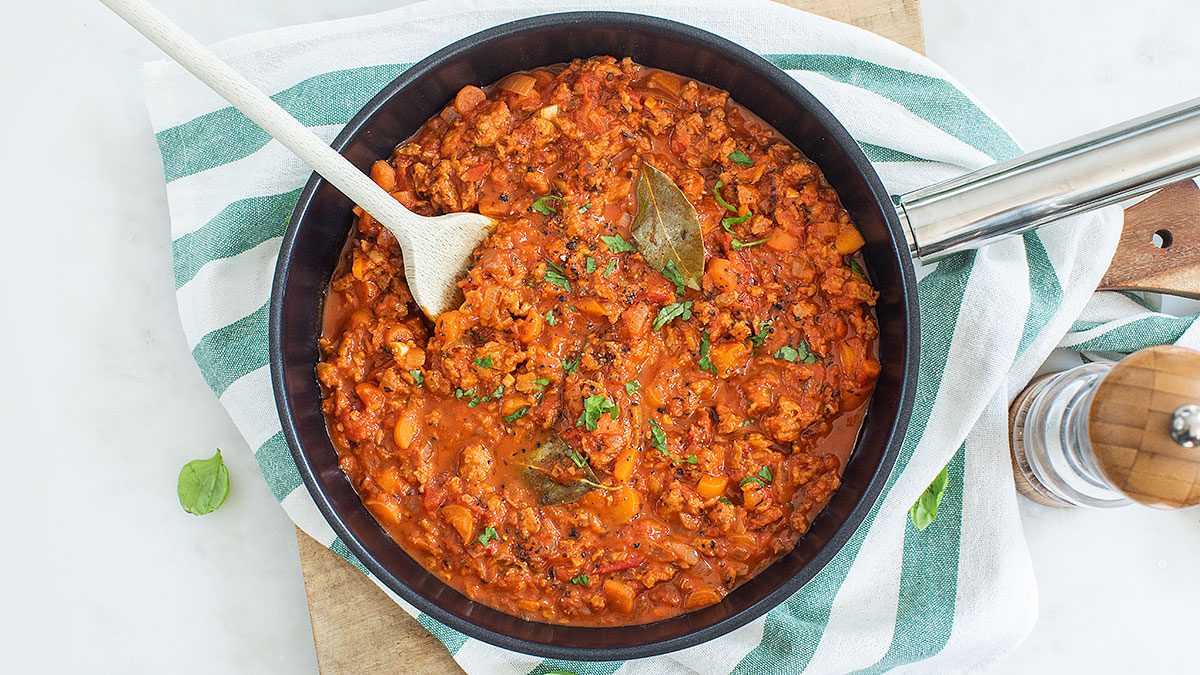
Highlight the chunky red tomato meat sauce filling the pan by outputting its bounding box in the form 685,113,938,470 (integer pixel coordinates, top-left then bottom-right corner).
317,56,880,626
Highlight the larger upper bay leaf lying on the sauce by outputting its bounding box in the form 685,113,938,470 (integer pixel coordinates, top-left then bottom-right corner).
632,162,704,291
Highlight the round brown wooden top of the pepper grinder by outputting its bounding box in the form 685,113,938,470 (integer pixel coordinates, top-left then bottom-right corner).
1087,347,1200,508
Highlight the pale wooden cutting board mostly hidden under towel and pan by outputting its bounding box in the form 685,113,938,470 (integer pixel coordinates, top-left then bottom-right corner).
296,0,925,675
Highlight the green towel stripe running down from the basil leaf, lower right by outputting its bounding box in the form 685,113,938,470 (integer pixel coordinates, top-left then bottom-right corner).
858,443,966,675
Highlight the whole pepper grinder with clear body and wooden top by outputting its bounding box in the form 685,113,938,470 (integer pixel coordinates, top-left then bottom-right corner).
1009,347,1200,508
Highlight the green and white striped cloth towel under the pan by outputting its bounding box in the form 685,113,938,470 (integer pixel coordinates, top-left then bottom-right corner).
144,0,1195,675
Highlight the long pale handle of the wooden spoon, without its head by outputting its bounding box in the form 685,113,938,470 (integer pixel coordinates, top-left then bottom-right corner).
100,0,424,238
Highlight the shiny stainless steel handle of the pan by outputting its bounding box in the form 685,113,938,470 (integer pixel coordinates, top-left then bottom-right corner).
895,98,1200,262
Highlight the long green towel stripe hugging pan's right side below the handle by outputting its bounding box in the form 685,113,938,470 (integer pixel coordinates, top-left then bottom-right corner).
733,251,976,675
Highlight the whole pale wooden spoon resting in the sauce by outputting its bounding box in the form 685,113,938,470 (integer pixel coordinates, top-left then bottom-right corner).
100,0,493,318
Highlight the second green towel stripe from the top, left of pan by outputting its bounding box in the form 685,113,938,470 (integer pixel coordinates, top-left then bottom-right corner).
170,189,300,289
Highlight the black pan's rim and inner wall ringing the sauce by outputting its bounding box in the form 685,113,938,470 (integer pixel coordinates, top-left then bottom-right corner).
270,12,919,661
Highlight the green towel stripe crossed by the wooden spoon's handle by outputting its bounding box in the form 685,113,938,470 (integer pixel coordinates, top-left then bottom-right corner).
155,64,412,183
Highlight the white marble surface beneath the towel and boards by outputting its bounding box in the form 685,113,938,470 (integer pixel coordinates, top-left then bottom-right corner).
0,0,1200,673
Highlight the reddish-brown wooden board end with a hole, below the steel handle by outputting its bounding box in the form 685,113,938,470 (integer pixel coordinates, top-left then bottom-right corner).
1100,180,1200,299
